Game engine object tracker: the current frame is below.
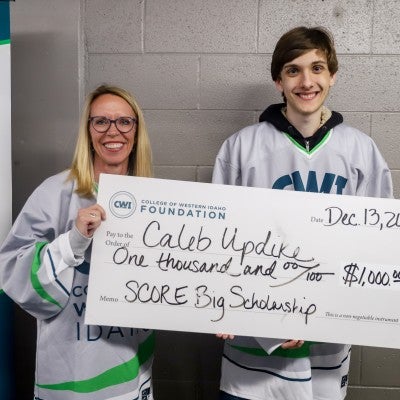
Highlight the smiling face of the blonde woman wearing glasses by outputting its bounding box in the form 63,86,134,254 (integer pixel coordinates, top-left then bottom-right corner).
89,94,137,175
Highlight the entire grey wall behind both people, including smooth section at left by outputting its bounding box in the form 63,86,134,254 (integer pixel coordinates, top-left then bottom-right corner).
7,0,400,400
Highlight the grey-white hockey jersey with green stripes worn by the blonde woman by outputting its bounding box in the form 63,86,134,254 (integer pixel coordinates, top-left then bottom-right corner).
0,172,154,400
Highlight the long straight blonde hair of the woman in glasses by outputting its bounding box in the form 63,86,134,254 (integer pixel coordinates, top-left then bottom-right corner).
69,85,152,197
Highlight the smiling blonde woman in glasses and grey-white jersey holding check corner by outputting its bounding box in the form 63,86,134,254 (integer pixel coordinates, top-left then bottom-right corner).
0,85,154,400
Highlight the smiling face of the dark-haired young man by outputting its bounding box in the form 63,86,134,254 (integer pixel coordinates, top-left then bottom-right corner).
275,49,335,118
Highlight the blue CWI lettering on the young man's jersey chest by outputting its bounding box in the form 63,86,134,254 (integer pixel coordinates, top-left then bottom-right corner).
272,171,347,194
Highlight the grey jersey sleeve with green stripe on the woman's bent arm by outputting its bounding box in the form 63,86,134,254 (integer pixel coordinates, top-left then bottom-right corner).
0,180,83,319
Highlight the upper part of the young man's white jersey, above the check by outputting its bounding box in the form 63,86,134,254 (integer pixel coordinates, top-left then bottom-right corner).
213,122,392,197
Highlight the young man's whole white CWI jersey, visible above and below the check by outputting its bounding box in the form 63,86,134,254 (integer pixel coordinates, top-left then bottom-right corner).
213,113,392,400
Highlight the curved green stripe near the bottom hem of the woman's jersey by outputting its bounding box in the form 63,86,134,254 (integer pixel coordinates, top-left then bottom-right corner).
36,332,155,393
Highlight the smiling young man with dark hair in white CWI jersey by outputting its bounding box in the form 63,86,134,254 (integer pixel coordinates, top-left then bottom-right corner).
213,27,392,400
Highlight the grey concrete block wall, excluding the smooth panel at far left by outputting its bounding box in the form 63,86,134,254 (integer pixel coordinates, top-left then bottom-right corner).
84,0,400,400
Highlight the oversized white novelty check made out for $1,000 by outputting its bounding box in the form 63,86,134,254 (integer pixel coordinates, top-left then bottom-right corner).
85,175,400,348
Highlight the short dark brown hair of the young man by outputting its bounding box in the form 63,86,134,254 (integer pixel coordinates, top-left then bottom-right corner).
271,26,338,81
